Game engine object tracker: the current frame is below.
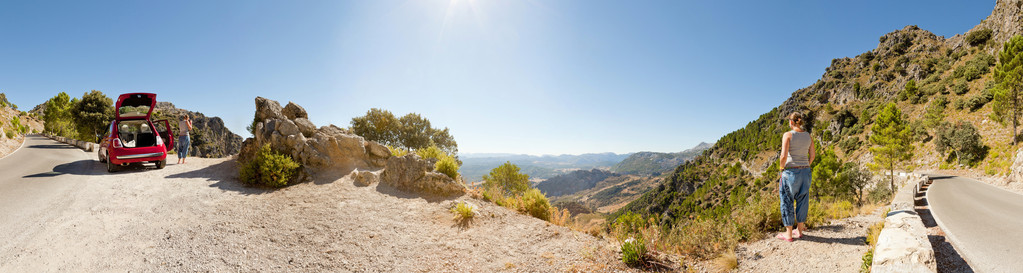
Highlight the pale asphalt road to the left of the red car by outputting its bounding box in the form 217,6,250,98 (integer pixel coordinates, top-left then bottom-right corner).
0,135,96,265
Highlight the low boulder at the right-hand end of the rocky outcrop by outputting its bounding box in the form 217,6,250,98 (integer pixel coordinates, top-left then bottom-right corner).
381,154,465,196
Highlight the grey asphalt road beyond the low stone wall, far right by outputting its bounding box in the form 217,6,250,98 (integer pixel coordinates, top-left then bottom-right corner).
927,175,1023,272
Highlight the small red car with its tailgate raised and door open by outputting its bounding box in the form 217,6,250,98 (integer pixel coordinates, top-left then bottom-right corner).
97,93,174,173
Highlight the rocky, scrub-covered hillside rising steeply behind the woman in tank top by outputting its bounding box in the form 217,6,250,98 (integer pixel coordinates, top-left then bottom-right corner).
613,1,1023,232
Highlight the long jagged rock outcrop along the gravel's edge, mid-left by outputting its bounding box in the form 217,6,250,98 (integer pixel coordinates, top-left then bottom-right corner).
238,97,464,196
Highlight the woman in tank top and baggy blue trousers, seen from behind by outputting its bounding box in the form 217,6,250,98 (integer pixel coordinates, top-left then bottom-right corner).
775,111,814,241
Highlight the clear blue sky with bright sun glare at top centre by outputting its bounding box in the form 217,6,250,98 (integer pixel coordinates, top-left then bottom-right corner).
0,0,994,154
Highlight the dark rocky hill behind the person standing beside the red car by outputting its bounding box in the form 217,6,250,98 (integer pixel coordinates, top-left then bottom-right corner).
153,101,241,157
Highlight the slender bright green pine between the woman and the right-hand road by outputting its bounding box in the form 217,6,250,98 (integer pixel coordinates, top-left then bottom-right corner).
870,102,914,192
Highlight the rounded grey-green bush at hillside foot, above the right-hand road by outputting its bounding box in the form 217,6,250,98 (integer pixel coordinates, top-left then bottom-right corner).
934,121,984,165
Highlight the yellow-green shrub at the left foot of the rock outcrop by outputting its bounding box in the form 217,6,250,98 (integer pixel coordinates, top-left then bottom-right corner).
238,144,301,187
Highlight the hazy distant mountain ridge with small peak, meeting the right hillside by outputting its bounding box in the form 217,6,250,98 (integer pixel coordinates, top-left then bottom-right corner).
611,142,714,176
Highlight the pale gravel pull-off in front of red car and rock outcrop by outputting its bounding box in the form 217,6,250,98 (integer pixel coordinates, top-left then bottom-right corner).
0,158,632,272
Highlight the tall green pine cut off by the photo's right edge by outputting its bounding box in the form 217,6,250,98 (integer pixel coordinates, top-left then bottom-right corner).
994,35,1023,145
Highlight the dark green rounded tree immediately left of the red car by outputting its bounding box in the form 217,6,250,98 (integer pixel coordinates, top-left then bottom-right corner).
72,90,114,142
